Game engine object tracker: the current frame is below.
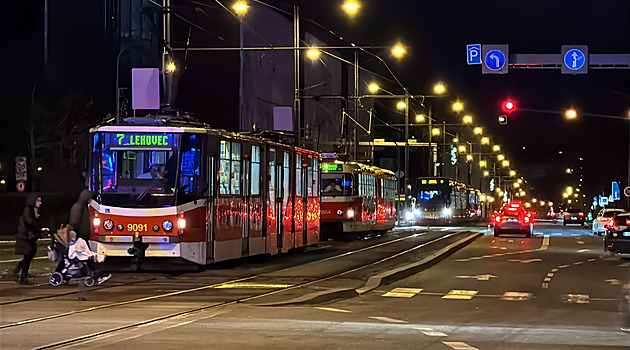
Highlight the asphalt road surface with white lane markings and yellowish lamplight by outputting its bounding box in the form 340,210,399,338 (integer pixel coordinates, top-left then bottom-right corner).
0,223,630,350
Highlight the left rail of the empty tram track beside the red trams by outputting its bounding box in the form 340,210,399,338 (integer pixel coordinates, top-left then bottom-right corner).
0,227,440,331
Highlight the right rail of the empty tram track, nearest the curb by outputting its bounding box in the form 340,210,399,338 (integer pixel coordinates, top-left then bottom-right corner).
30,232,474,349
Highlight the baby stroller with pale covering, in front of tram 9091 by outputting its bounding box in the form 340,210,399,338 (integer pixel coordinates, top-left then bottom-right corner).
48,225,111,287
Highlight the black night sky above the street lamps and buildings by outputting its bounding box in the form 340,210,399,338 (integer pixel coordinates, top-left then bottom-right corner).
0,0,630,205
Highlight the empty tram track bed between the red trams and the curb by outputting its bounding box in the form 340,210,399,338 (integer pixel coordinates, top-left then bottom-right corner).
0,226,482,349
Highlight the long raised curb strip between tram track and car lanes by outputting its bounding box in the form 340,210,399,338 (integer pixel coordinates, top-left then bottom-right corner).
251,232,483,306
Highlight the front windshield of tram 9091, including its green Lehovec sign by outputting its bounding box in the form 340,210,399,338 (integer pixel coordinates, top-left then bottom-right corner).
92,133,202,207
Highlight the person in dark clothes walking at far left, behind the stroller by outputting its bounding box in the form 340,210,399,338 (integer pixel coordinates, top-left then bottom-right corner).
13,193,50,284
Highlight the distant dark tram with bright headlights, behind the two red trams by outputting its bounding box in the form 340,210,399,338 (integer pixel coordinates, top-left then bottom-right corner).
405,177,482,224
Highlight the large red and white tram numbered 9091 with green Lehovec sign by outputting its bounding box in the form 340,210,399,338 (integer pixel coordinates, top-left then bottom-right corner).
89,116,320,265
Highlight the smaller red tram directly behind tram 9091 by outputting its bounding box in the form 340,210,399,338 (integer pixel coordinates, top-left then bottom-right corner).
321,160,397,234
